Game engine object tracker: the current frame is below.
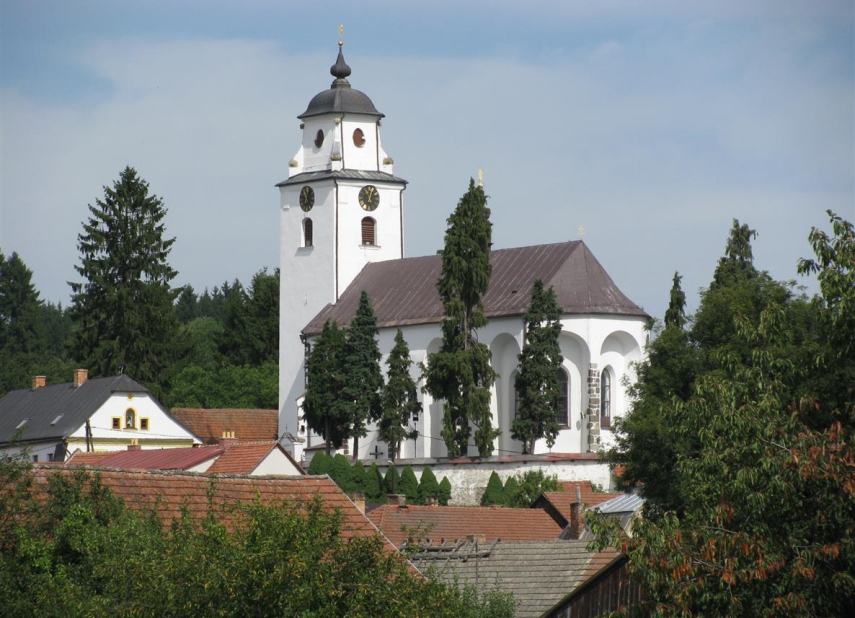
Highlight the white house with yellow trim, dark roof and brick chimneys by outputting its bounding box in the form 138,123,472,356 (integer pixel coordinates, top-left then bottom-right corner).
0,369,202,461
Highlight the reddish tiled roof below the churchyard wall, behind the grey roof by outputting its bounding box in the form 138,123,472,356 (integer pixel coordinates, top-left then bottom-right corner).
368,504,562,547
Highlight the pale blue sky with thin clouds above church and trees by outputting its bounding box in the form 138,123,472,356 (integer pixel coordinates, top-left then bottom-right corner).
0,0,855,318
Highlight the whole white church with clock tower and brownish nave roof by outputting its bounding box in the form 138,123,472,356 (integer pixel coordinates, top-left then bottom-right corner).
276,42,649,460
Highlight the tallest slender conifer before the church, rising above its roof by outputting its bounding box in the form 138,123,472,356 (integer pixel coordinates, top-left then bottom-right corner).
425,179,501,457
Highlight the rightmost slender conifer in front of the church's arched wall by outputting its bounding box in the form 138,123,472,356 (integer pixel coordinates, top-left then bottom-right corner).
511,279,563,453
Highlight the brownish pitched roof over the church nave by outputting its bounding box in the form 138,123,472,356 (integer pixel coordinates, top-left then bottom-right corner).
303,241,648,335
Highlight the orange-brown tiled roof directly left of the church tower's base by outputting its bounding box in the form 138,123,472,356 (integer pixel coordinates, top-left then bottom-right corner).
172,408,279,444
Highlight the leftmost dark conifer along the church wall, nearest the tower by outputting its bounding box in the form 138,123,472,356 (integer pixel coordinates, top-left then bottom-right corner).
303,320,350,455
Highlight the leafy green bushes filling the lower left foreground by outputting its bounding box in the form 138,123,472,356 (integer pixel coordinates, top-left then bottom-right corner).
0,463,514,618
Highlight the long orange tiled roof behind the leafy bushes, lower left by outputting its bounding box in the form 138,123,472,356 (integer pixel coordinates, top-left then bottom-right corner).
32,465,395,551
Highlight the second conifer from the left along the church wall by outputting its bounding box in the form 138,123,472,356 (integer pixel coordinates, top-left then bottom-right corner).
344,290,383,457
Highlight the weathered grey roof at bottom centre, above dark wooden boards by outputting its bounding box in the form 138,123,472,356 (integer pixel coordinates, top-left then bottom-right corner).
411,541,594,618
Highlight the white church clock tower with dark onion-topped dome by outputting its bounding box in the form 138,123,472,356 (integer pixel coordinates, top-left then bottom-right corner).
276,41,407,457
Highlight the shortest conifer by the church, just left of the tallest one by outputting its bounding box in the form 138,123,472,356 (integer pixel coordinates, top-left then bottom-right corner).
378,329,422,461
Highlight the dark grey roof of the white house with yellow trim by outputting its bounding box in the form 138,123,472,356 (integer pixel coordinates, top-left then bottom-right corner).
0,375,148,444
